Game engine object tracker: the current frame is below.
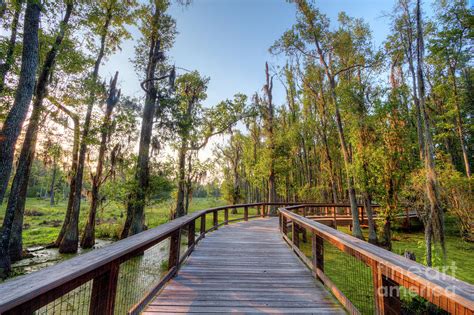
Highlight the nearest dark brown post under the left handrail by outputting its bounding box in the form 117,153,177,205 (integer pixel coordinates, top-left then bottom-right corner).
89,263,119,315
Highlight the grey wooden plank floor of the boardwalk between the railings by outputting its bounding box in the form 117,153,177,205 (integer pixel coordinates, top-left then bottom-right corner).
143,218,345,314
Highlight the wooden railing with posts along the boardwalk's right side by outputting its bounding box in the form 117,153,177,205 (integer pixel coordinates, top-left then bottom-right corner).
279,205,474,314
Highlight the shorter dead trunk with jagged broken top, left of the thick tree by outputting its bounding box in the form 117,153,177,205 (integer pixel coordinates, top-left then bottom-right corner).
81,72,120,248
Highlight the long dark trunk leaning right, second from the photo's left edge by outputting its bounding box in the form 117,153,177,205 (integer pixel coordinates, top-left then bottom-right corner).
1,4,73,261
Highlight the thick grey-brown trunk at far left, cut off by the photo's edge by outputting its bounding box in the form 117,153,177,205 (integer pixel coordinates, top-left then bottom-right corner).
0,0,41,205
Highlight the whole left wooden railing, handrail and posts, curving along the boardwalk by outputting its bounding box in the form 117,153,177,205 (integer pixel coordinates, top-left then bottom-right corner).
0,203,314,315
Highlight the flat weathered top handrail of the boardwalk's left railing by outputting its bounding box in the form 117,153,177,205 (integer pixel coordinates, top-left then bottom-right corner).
0,202,334,313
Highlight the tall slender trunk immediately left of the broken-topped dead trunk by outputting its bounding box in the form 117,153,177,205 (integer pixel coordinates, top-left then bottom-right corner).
59,8,113,253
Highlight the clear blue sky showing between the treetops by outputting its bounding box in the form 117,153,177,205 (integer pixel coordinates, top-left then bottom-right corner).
102,0,418,106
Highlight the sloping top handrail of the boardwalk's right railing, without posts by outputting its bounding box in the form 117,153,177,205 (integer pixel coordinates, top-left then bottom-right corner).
279,205,474,310
